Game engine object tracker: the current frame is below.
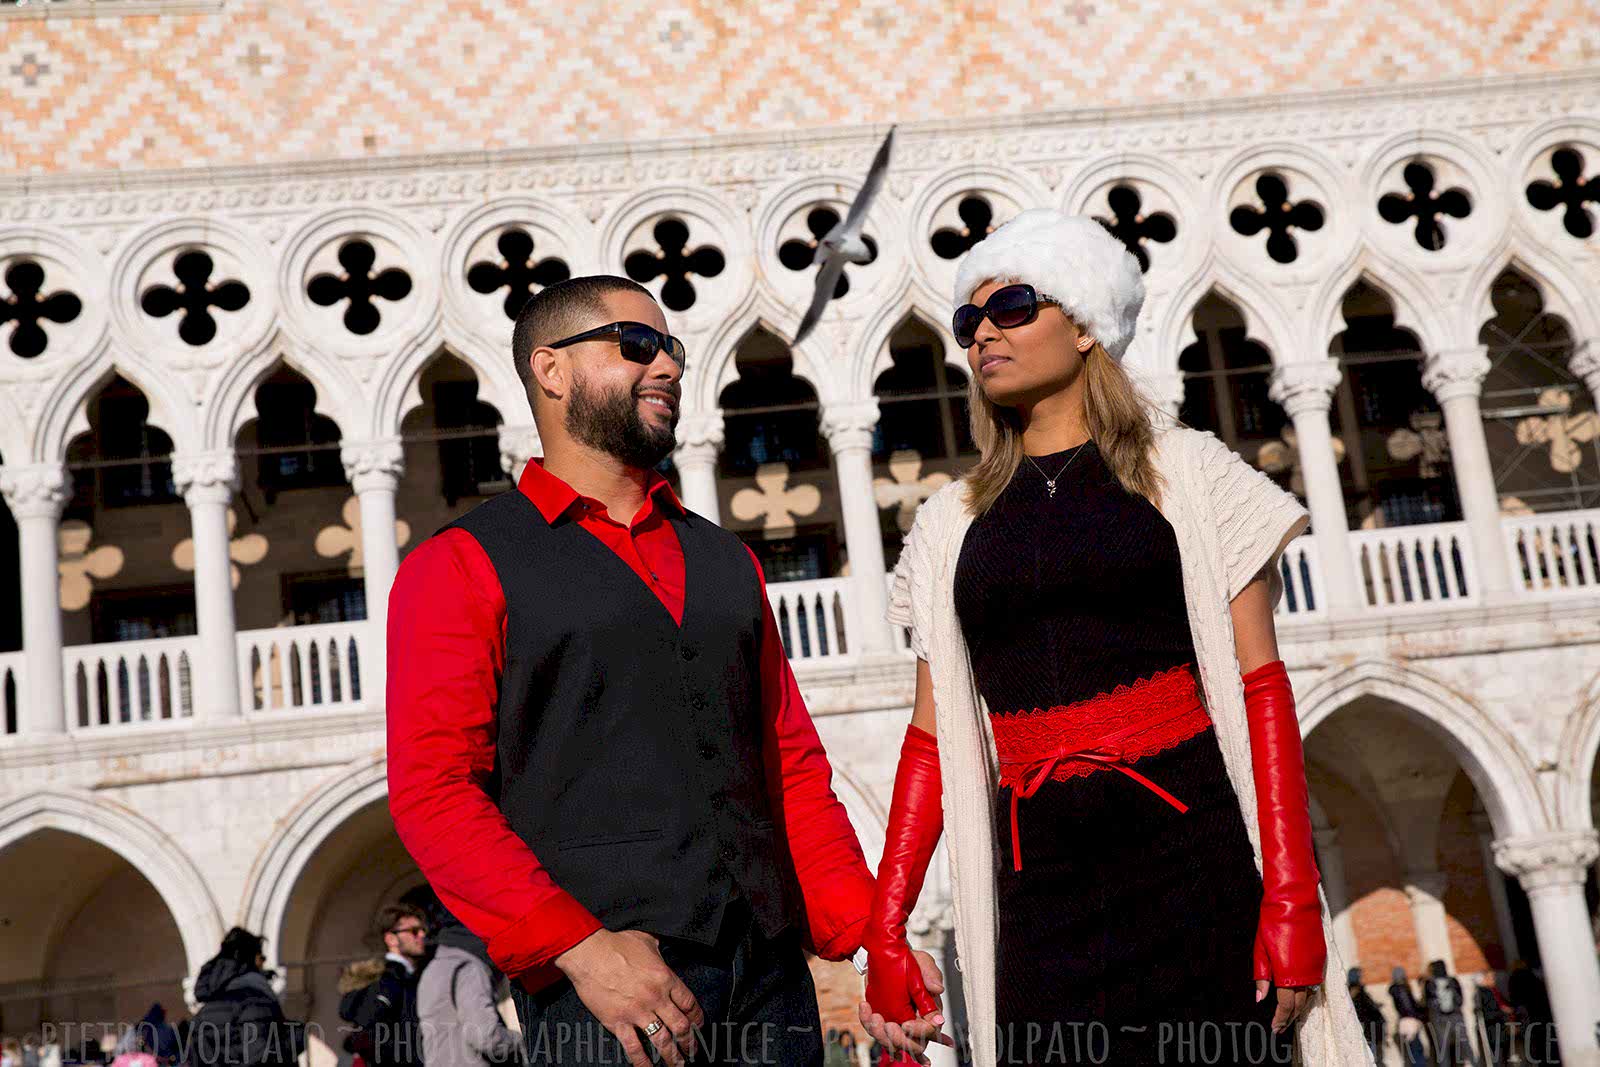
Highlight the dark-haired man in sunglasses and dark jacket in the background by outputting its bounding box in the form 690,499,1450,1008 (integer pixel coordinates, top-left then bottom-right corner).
339,904,427,1067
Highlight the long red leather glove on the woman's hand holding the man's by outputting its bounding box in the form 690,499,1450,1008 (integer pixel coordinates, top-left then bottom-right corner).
862,726,944,1022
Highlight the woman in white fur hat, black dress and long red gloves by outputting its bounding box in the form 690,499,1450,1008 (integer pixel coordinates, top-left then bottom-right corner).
862,211,1371,1067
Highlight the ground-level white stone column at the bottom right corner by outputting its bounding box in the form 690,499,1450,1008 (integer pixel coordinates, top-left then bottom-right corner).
1494,830,1600,1067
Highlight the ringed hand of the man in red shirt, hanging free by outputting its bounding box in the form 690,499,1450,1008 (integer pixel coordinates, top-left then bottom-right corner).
555,929,706,1067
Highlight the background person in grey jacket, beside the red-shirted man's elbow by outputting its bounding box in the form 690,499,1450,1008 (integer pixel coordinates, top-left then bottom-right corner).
416,904,522,1067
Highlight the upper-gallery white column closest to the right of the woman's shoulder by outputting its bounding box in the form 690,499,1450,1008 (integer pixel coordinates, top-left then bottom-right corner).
1267,360,1365,613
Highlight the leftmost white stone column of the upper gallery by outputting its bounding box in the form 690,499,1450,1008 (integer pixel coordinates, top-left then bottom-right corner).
0,464,72,734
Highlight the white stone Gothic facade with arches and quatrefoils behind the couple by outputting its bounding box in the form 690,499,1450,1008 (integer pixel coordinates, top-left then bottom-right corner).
0,16,1600,1067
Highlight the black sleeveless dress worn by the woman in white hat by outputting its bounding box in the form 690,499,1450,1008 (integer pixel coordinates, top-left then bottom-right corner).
955,442,1291,1064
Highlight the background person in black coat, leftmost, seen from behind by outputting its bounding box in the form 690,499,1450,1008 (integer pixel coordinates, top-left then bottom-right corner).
184,926,306,1067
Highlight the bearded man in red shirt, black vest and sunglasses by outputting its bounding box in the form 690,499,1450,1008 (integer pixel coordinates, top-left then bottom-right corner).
389,277,941,1067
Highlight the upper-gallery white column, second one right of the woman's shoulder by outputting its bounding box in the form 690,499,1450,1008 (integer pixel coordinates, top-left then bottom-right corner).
1422,346,1510,600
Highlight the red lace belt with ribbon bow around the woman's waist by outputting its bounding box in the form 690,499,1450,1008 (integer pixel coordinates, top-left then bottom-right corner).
989,664,1211,870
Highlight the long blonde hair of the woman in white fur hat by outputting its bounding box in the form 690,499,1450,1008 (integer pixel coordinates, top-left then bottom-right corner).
965,341,1163,515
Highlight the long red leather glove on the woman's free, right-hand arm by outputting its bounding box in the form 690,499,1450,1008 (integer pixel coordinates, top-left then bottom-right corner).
1245,659,1328,987
